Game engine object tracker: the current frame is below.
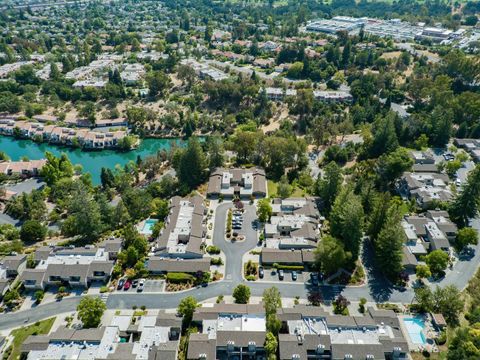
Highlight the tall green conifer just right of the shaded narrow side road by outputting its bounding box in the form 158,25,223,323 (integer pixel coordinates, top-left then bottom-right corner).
373,204,405,281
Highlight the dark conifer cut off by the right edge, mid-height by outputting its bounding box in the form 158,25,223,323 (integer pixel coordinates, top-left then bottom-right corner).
449,164,480,228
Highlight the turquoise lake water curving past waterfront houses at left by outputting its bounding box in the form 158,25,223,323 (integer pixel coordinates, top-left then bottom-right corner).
0,136,186,185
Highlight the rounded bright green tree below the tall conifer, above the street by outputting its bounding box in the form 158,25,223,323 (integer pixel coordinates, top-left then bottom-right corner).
315,235,351,275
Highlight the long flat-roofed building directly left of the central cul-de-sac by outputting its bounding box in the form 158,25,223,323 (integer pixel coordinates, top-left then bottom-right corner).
147,195,210,273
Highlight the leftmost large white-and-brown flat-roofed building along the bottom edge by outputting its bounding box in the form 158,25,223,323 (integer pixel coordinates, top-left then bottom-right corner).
21,312,182,360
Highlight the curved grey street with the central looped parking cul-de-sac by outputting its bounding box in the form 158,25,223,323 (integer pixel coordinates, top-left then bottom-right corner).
0,203,480,329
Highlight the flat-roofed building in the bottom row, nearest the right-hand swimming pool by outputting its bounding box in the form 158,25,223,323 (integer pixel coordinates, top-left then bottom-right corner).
278,305,408,360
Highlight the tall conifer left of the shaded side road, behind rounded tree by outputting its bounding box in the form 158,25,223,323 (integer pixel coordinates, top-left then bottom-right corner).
330,187,364,261
